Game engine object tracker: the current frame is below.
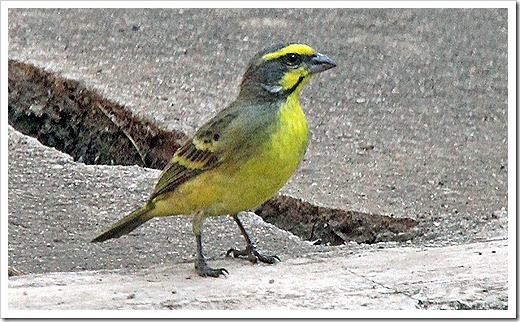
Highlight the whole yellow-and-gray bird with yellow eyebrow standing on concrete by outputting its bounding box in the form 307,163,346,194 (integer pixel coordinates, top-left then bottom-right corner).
91,43,336,277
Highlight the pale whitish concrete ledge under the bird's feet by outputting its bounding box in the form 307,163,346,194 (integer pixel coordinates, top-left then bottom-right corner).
8,240,508,310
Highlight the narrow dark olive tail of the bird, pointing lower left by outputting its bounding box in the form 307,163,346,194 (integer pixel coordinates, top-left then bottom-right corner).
90,204,154,243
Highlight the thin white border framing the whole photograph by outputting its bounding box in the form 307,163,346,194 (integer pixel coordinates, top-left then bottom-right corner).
0,1,517,318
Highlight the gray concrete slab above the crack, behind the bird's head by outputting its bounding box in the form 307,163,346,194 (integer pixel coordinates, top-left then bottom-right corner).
9,9,508,216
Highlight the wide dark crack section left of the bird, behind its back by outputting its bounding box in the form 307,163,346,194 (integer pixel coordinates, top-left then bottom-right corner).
8,60,186,169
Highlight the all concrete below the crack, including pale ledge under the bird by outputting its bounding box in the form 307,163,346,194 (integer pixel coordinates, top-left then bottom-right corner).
4,128,514,317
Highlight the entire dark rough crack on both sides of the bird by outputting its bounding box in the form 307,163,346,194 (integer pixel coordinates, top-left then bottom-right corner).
8,60,418,245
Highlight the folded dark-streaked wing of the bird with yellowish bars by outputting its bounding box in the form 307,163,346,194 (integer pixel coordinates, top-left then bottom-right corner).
150,109,237,200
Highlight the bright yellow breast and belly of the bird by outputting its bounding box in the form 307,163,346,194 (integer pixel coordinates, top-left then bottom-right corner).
155,99,308,216
